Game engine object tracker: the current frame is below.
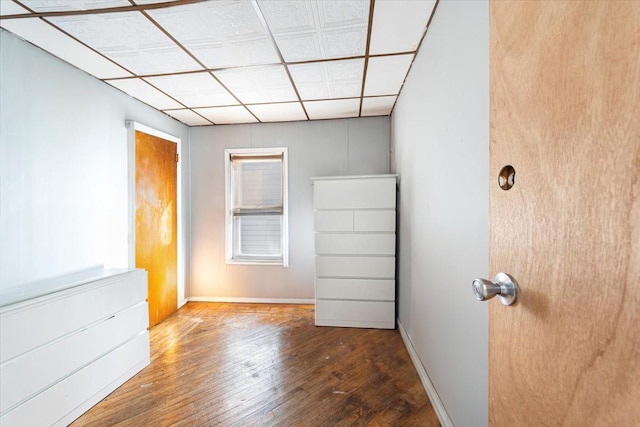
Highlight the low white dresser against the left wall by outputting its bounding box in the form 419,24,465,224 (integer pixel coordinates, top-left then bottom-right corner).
0,270,149,426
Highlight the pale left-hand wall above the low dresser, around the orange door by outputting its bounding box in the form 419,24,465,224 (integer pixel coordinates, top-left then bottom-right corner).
0,30,189,289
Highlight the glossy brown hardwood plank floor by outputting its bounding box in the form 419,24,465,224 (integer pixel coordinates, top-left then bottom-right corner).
72,303,440,426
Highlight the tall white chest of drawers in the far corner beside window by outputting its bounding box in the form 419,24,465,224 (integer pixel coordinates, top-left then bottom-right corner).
313,175,397,329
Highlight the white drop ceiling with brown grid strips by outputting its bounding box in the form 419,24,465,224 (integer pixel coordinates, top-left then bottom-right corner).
0,0,437,126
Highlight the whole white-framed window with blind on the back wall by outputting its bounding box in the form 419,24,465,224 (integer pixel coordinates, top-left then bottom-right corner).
225,148,289,267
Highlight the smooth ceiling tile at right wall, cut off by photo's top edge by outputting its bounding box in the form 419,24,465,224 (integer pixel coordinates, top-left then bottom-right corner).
369,0,436,55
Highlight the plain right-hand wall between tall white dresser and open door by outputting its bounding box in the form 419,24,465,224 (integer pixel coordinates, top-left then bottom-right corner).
391,1,489,427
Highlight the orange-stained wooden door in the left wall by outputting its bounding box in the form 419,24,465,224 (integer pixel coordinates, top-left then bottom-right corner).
136,131,178,326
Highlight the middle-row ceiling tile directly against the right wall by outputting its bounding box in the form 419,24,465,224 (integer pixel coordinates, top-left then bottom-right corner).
364,54,414,96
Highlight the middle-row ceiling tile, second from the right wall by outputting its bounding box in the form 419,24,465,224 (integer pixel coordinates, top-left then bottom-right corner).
289,59,364,100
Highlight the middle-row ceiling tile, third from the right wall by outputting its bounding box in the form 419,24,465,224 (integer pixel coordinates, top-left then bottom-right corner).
214,65,297,104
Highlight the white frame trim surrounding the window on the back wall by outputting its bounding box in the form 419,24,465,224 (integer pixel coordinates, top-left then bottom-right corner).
224,147,289,267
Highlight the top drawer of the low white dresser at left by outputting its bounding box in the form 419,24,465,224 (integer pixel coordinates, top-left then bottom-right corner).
0,270,147,363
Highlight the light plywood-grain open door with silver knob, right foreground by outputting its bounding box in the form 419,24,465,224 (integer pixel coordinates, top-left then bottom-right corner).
489,1,640,426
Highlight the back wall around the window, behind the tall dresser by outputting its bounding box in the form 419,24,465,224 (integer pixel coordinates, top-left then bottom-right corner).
190,117,389,299
